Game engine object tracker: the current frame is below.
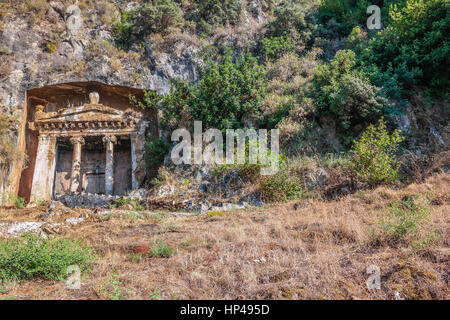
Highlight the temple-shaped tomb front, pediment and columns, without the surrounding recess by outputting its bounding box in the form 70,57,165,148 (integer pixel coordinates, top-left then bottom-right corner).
29,92,148,200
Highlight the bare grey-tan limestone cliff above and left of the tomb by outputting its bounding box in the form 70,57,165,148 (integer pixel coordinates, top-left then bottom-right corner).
0,0,265,199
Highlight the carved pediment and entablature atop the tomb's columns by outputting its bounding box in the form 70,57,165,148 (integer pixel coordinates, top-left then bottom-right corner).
29,92,142,136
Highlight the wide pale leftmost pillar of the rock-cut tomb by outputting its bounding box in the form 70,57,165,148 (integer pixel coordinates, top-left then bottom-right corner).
30,135,56,202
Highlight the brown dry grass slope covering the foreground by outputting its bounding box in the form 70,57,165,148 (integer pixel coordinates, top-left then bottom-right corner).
0,173,450,299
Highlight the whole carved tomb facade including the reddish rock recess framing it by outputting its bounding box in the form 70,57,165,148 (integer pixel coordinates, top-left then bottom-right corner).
17,84,158,202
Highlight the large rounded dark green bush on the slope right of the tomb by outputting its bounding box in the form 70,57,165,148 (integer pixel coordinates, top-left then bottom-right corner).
188,49,265,129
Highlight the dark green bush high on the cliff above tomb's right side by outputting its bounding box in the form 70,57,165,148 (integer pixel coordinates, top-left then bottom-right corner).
113,0,184,49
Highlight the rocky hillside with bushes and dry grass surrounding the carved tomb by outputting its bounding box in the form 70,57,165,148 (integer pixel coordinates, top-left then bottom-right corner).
0,0,450,300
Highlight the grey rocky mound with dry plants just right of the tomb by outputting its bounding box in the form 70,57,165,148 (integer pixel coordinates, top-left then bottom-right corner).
141,158,263,213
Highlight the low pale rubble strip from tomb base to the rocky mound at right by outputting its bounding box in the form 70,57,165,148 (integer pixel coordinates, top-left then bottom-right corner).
54,166,262,213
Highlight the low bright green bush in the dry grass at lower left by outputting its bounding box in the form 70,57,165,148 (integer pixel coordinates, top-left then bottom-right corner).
0,235,93,281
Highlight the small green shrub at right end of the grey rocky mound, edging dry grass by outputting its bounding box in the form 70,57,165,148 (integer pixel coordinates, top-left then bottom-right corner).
260,168,304,202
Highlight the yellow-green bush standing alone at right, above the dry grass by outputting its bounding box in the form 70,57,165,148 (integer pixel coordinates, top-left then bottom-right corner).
351,118,404,186
